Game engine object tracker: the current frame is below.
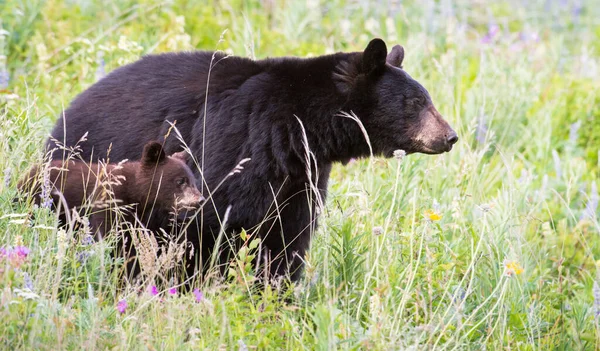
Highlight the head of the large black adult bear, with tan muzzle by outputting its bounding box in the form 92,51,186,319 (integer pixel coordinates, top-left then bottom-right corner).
334,39,458,157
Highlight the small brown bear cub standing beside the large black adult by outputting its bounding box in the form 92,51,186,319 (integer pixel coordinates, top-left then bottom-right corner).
18,141,204,238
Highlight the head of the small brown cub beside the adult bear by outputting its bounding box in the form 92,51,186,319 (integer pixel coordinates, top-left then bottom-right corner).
134,141,204,213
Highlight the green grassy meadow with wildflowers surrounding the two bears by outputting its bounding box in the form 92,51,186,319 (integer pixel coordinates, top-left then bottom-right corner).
0,0,600,350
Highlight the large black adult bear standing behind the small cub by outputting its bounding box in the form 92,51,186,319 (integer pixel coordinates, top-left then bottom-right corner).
48,39,458,280
